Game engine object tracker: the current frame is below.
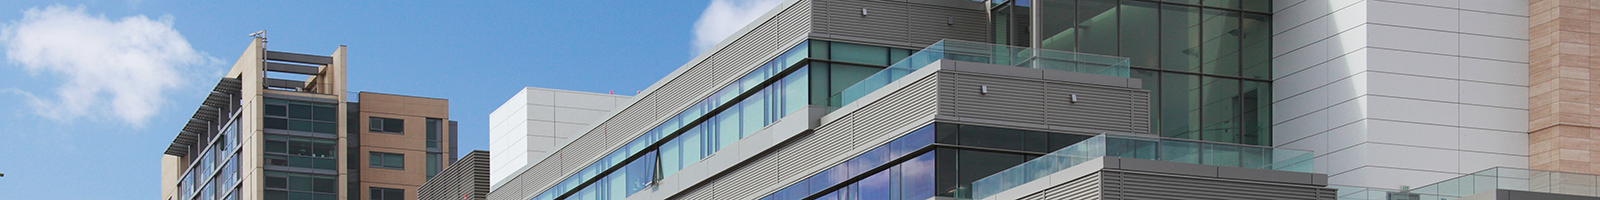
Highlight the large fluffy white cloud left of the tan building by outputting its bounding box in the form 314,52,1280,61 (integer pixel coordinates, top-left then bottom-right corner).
0,5,213,126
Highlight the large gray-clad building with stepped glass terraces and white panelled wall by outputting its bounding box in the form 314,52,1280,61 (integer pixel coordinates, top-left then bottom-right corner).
457,0,1600,200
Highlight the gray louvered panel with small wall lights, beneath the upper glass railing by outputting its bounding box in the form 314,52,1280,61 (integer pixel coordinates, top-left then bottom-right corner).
939,62,1149,134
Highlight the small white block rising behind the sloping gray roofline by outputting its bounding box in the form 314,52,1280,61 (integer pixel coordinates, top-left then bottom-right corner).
490,88,629,190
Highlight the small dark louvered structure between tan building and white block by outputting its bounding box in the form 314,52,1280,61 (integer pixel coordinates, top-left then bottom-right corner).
416,150,490,200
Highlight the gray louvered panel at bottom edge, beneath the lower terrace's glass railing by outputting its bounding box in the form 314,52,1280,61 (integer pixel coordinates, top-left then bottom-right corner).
1101,170,1334,200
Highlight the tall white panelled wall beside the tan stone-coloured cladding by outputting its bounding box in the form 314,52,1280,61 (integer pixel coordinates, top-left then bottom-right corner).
1272,0,1528,189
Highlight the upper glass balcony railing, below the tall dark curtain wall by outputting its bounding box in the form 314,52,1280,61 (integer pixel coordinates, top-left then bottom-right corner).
827,40,1128,106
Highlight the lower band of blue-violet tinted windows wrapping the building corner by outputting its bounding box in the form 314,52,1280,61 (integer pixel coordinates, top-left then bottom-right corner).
762,123,1093,200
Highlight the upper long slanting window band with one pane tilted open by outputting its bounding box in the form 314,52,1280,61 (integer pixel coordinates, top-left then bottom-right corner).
533,40,912,200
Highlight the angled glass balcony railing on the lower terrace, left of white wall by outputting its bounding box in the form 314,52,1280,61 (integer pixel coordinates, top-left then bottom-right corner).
971,134,1314,200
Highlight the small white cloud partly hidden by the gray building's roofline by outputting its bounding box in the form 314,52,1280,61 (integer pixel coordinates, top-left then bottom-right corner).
693,0,782,54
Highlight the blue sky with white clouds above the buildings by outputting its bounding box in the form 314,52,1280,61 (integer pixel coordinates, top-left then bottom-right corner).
0,0,774,200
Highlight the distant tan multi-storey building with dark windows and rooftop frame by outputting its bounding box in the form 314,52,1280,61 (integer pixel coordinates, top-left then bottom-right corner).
162,37,456,200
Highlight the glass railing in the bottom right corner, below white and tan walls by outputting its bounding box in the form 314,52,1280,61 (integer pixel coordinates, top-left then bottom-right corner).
1338,166,1600,200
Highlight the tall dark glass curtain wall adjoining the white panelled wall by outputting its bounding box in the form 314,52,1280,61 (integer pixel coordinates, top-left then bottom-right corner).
1017,0,1272,146
